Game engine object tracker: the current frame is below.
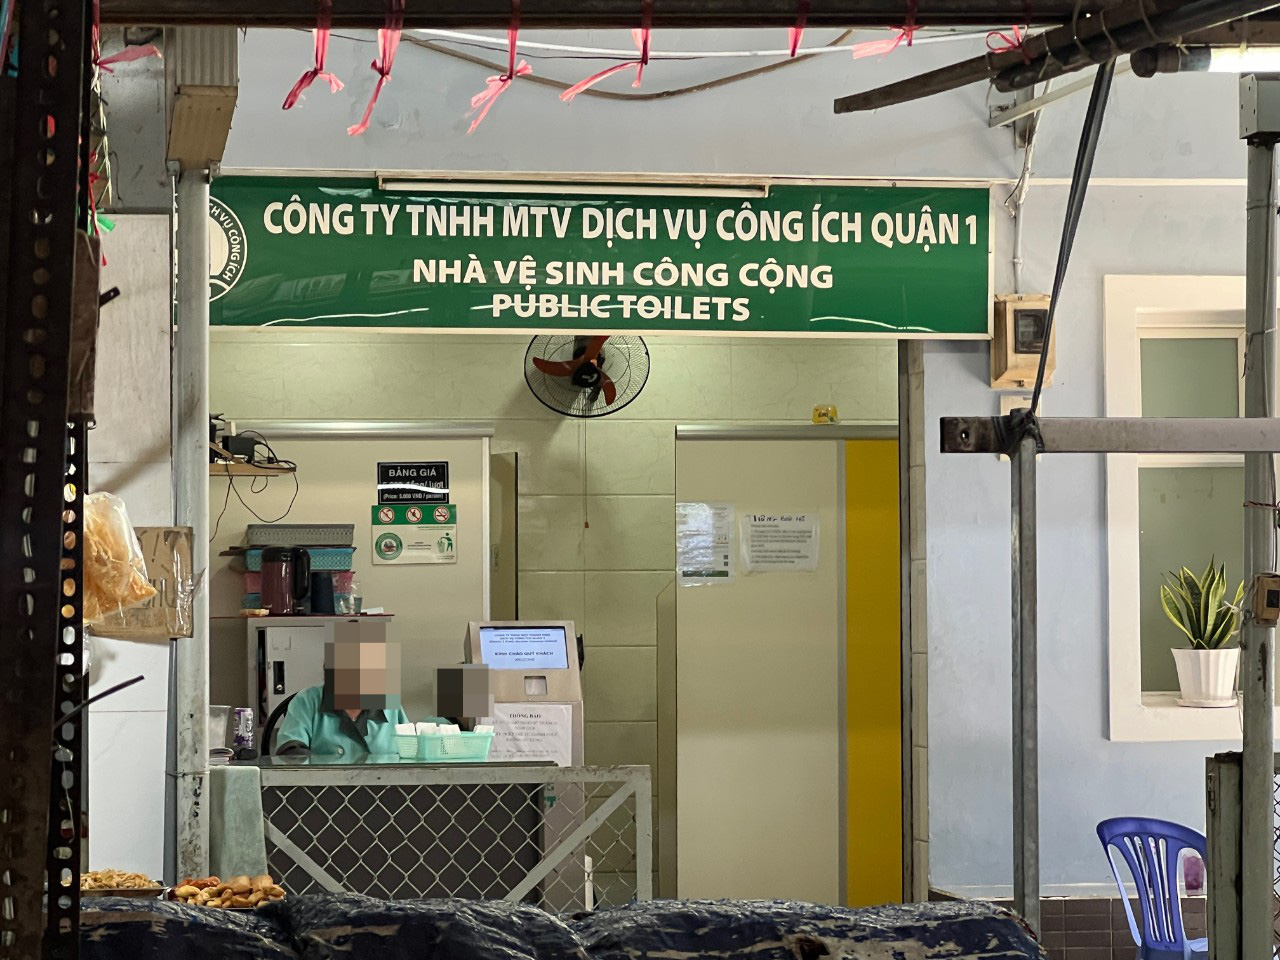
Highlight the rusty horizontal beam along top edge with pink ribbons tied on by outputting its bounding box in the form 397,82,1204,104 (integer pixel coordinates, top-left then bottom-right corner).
101,0,1115,29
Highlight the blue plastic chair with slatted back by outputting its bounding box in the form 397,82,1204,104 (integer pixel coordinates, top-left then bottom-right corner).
1098,817,1208,960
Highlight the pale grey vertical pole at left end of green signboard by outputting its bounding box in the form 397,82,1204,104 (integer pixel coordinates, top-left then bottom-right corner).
172,170,209,879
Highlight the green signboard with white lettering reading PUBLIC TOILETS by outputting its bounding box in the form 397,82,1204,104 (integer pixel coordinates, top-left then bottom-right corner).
209,177,991,338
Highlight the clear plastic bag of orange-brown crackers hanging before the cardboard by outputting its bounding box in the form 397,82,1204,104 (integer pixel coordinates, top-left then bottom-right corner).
84,493,156,623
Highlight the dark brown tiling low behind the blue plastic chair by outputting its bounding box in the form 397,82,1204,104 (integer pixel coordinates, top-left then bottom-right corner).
997,897,1206,960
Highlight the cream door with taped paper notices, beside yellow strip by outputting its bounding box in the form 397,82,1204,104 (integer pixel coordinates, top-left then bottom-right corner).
676,440,844,904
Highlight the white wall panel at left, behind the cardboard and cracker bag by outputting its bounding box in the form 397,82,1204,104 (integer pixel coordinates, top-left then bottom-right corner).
87,215,173,878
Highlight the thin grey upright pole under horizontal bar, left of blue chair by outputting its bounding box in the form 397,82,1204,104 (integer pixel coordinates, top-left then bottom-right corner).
1010,436,1041,933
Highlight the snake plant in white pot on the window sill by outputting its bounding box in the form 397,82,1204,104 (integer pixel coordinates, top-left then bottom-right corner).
1160,559,1244,707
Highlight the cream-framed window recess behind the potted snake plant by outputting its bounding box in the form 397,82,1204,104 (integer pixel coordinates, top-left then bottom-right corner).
1105,276,1274,741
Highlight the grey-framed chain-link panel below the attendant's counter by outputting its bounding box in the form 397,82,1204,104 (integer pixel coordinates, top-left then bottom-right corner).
261,765,653,913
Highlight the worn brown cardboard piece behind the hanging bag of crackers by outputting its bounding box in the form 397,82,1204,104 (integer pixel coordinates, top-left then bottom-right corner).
90,526,196,640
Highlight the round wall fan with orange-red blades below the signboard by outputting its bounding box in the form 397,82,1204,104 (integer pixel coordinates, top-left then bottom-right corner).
525,337,649,417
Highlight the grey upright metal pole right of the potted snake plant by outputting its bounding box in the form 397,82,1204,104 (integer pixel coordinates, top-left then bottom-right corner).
1240,90,1276,957
